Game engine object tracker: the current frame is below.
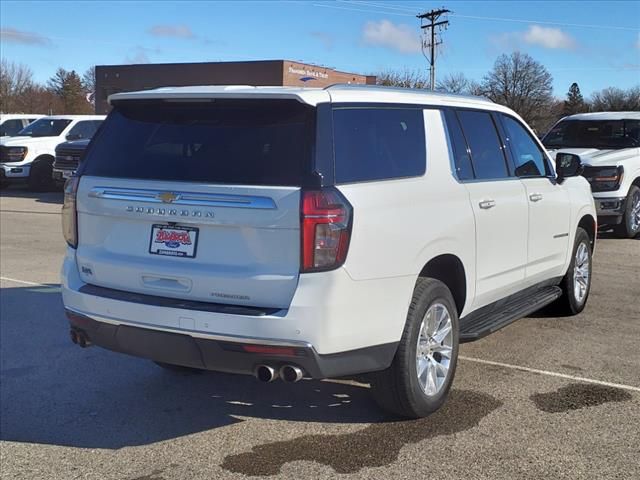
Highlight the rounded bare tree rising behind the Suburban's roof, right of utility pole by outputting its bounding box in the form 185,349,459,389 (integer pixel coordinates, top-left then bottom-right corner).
481,52,553,130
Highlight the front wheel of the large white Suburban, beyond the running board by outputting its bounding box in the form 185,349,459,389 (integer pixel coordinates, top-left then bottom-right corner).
555,227,592,316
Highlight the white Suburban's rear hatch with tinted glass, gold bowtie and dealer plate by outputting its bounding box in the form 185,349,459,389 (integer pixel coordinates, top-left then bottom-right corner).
76,99,315,308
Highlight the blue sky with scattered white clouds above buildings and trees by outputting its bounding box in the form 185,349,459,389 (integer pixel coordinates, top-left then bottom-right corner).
0,0,640,97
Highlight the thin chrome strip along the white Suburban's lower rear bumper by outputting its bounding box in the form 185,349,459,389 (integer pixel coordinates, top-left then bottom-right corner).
64,306,313,348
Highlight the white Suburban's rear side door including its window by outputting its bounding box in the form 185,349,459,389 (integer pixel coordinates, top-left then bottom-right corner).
456,110,528,307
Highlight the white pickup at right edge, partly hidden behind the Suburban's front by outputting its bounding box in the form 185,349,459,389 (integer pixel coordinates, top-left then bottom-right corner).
542,112,640,238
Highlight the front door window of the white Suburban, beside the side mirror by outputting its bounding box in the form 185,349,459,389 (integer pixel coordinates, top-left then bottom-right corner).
502,115,549,177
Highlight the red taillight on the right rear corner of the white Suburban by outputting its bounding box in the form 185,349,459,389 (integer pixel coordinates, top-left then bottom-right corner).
300,188,353,273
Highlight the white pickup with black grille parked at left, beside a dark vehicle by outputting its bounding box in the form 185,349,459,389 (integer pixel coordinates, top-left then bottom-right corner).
0,115,105,190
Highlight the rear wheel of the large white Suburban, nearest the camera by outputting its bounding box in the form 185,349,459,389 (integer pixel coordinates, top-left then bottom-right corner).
369,278,459,418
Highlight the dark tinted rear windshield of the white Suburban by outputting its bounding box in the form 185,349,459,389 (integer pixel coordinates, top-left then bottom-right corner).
82,100,313,186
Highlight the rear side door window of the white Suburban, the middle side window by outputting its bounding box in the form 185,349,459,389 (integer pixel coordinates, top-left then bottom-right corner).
458,110,509,180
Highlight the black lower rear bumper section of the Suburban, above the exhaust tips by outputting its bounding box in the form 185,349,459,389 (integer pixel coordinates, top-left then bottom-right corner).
67,310,397,379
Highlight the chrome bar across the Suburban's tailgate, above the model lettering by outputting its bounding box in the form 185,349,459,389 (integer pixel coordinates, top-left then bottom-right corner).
89,187,276,210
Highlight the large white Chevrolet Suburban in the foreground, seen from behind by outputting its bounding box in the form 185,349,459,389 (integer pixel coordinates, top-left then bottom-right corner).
62,86,596,417
